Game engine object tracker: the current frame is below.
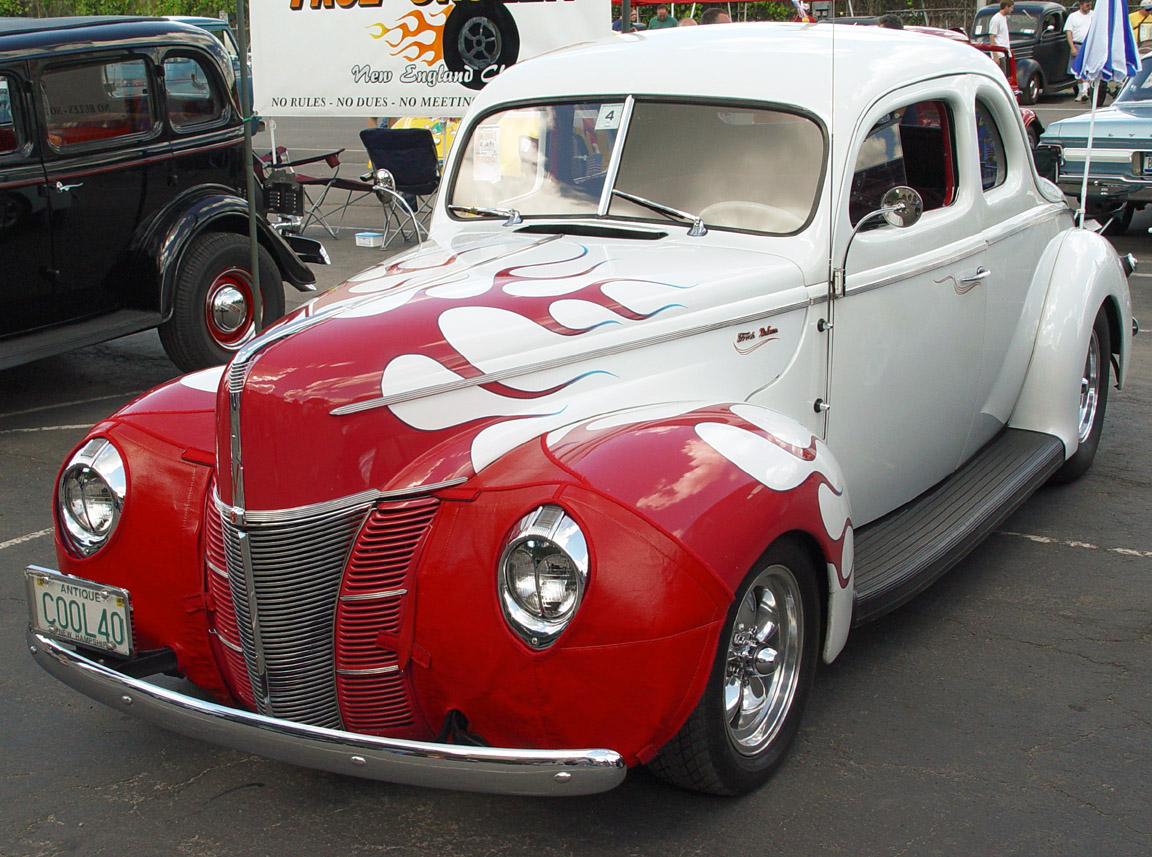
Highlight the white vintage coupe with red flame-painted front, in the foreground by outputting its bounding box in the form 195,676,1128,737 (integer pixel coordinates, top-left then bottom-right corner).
26,24,1132,795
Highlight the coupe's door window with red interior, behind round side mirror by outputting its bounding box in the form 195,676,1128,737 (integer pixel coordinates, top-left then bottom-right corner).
848,101,956,225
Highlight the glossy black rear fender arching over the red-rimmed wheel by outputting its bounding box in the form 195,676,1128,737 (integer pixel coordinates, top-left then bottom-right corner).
132,184,316,318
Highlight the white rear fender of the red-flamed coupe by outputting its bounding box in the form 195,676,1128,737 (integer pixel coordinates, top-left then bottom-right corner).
1008,229,1132,457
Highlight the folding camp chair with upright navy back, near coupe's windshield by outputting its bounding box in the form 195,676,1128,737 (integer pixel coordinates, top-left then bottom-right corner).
361,128,440,247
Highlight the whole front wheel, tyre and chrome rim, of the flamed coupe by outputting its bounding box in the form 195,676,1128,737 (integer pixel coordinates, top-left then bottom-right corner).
649,538,820,795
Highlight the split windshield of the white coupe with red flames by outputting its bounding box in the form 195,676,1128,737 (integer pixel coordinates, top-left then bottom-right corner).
448,99,825,234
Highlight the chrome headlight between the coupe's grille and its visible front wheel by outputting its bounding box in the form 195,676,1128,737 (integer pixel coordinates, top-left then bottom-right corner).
499,505,589,649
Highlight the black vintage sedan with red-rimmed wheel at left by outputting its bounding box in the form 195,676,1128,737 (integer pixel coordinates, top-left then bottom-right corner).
0,17,323,371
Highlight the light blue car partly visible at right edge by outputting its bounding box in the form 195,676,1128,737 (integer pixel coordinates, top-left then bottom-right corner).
1040,55,1152,234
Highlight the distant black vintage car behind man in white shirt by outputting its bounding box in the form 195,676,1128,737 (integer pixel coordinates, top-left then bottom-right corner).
971,2,1076,104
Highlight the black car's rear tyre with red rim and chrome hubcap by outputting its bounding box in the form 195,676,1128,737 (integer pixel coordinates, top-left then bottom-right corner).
160,233,285,372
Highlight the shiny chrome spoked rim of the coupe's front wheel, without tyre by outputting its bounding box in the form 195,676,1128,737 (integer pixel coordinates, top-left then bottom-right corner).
723,566,804,756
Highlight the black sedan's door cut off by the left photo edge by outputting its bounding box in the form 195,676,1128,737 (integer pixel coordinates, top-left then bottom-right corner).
0,62,52,338
